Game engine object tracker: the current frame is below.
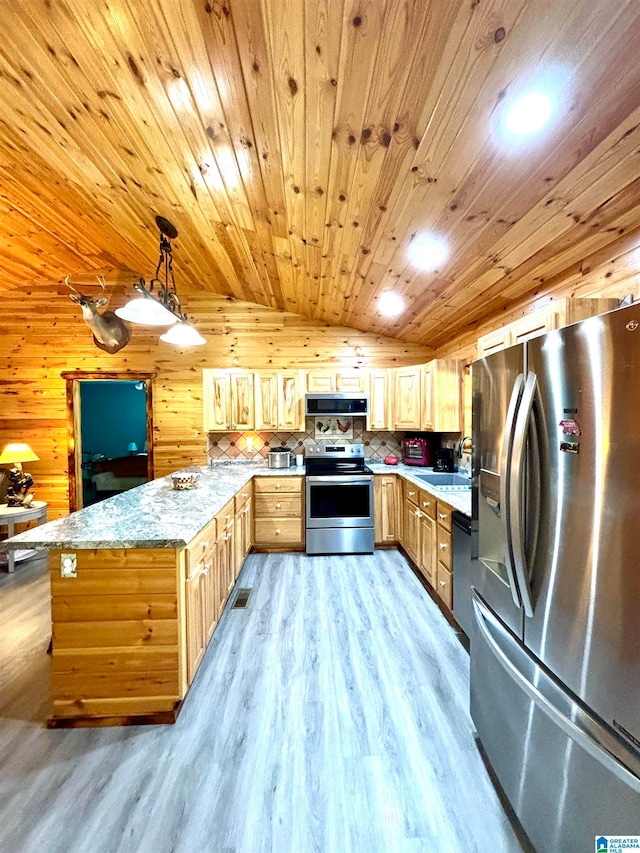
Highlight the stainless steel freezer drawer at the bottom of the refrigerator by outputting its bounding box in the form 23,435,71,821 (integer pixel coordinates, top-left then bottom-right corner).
471,594,640,853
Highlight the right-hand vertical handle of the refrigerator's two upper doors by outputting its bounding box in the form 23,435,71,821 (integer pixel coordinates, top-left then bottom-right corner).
509,372,538,616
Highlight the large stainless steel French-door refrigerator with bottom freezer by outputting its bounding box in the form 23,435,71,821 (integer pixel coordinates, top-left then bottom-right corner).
471,305,640,853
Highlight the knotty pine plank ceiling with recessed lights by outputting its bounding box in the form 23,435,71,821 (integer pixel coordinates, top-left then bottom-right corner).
0,0,640,347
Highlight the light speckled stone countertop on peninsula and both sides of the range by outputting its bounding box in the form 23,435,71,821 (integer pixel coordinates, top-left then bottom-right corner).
3,461,471,550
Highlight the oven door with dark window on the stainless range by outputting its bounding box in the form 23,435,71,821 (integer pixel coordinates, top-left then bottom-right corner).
306,474,373,528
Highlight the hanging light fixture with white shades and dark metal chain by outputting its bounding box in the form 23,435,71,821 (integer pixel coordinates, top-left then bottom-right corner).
115,216,206,346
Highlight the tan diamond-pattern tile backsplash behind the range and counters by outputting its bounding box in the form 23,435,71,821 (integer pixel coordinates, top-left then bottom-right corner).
207,418,404,461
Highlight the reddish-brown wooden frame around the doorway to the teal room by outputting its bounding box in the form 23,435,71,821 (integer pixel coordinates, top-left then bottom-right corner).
61,370,158,512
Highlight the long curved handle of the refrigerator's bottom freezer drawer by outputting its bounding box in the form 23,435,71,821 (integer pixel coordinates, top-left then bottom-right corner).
472,590,640,793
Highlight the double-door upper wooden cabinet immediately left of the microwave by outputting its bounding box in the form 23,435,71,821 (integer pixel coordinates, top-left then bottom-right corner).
254,370,305,432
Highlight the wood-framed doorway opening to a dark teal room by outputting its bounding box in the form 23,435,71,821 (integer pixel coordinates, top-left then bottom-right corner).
63,371,155,512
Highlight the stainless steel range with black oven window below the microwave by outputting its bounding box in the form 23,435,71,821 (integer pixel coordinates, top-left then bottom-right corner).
305,444,374,554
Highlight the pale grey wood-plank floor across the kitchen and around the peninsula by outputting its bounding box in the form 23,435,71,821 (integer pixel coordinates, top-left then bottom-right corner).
0,551,522,853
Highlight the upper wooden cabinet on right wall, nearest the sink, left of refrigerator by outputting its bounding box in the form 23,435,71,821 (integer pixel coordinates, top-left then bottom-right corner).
422,358,462,432
